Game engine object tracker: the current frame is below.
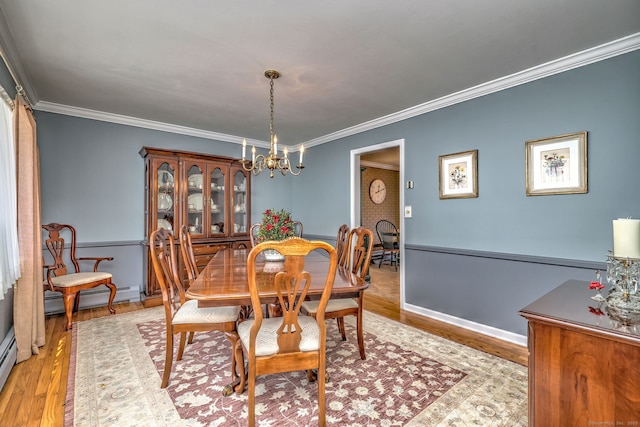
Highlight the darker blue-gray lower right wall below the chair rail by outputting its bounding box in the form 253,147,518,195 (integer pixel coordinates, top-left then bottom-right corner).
404,245,606,336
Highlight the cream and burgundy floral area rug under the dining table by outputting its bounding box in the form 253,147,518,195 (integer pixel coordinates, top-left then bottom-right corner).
65,307,527,427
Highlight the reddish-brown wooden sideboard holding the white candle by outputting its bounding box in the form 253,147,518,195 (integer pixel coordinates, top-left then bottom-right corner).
520,280,640,427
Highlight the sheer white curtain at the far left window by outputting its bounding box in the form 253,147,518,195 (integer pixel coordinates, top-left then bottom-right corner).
0,95,20,299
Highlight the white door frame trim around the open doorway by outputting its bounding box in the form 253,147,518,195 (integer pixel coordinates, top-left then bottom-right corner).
350,138,406,308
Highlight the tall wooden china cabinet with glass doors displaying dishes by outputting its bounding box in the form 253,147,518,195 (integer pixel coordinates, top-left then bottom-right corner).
140,147,251,305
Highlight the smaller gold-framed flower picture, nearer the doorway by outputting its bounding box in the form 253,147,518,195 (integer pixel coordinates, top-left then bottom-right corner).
438,150,478,199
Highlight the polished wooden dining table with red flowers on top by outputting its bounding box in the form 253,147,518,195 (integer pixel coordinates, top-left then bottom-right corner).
186,248,369,395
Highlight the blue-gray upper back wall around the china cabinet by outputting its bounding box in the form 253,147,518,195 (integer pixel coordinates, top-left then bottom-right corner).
35,115,291,242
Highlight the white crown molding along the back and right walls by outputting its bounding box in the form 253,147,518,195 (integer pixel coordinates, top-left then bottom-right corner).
30,31,640,152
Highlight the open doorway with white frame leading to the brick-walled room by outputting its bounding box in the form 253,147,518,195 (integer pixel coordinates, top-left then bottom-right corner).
351,139,405,308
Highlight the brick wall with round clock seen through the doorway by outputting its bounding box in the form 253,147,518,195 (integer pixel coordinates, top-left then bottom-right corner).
361,167,400,243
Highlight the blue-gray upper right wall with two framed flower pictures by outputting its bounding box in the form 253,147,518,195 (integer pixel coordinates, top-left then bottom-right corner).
293,51,640,268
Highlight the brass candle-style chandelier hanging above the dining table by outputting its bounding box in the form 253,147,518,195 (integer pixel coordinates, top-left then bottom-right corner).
242,70,304,178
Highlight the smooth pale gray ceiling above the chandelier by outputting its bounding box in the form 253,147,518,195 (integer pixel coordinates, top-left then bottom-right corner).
0,0,640,150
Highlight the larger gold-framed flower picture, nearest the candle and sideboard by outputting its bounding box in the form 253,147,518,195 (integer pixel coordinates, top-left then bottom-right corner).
525,131,588,196
